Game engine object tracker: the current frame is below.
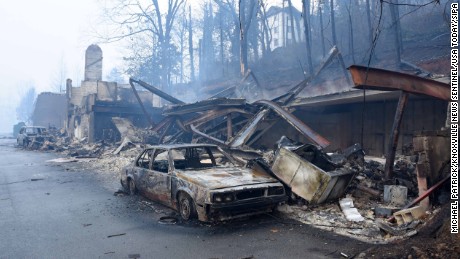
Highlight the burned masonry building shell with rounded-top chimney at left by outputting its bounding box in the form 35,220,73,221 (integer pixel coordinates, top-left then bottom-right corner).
66,45,164,143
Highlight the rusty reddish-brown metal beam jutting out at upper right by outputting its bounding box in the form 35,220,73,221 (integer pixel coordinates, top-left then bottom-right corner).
348,65,451,101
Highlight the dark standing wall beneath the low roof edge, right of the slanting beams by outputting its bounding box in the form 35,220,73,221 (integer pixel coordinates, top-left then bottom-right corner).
256,96,447,156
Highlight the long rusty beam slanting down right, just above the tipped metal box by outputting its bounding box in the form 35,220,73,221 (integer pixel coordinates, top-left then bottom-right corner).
256,100,330,148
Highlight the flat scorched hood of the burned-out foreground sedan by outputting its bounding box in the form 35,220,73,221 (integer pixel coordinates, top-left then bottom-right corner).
176,167,278,189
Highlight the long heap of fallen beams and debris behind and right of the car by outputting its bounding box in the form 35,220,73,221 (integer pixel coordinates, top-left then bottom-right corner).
24,54,449,246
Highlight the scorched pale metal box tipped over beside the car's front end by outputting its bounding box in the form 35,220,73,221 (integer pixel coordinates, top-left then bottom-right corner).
272,147,354,204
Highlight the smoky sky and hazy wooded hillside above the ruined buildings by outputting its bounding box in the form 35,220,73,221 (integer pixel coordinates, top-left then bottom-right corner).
0,0,449,132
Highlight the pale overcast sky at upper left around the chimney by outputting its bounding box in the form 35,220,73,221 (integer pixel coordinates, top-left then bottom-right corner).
0,0,119,132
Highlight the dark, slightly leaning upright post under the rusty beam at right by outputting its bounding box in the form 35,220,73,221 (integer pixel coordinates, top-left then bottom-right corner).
385,91,409,180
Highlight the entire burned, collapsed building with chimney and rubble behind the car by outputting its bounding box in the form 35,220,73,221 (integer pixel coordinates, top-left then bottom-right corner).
31,42,450,246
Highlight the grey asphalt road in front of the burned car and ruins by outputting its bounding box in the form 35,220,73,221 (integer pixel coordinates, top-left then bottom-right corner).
0,139,369,258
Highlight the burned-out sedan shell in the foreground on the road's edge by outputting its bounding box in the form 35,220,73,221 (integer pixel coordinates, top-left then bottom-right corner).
121,144,287,222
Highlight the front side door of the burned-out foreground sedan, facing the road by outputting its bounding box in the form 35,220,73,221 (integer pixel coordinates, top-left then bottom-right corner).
146,149,171,206
